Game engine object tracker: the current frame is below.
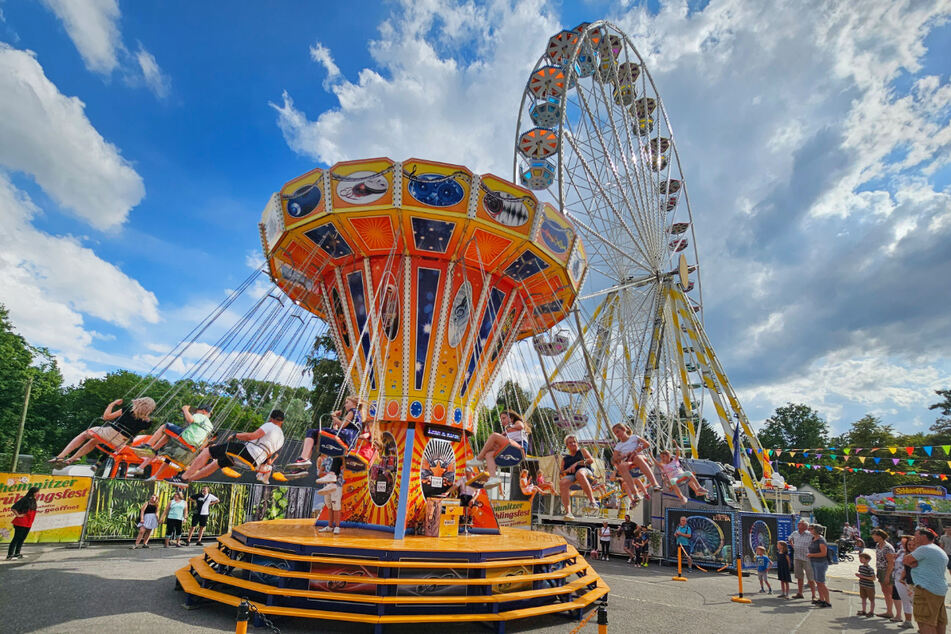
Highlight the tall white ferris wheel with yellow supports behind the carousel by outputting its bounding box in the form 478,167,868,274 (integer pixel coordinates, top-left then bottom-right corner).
513,21,763,512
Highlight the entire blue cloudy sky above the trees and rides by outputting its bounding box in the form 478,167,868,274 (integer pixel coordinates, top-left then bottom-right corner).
0,0,951,431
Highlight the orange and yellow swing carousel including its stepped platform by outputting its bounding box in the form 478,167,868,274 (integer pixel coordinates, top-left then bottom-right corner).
177,158,608,631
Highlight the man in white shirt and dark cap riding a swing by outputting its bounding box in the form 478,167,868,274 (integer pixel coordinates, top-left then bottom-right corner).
174,409,284,487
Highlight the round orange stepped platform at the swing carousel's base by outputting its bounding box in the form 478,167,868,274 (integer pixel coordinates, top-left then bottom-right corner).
176,519,609,632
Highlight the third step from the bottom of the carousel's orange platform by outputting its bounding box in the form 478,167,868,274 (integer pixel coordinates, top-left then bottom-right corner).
202,546,588,586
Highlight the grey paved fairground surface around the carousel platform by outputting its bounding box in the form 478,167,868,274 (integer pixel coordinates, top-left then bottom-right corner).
0,543,944,634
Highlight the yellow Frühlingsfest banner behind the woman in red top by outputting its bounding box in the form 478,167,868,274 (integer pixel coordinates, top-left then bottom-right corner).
0,473,92,542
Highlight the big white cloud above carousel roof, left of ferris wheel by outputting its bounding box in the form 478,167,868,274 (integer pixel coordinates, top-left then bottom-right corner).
272,0,560,175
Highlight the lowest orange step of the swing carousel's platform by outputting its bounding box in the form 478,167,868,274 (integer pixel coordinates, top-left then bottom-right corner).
175,568,610,624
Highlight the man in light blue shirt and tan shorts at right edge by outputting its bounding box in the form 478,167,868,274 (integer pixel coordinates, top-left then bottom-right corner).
902,527,948,634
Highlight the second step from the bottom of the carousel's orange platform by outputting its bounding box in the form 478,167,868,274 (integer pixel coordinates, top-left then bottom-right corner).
189,557,599,605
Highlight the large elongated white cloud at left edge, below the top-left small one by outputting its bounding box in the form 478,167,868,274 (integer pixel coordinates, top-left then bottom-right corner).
0,43,145,229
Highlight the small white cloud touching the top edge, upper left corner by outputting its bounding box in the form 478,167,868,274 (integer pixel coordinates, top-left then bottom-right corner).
43,0,122,75
